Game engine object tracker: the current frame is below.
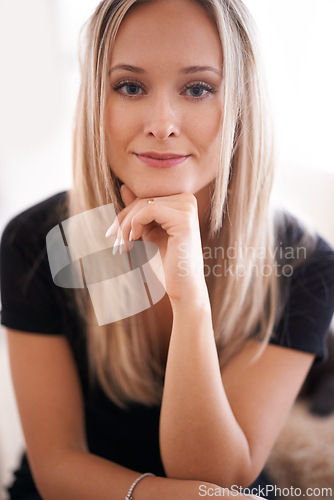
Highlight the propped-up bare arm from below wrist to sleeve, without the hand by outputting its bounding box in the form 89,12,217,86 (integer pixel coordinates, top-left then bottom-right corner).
160,299,314,488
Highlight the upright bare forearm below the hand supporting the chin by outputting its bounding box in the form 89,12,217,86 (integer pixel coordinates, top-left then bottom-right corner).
160,300,251,487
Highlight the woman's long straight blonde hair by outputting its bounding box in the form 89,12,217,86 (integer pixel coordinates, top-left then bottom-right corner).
69,0,279,407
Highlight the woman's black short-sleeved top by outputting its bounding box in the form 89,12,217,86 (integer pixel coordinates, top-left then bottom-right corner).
1,193,334,498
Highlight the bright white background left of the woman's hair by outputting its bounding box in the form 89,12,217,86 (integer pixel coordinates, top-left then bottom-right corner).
0,0,97,231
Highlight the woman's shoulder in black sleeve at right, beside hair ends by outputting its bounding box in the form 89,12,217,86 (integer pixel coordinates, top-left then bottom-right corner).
271,213,334,361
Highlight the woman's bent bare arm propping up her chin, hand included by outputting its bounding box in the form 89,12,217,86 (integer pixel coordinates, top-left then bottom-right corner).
109,186,313,488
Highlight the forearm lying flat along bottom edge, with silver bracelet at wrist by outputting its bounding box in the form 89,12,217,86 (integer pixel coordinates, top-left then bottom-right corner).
37,451,212,500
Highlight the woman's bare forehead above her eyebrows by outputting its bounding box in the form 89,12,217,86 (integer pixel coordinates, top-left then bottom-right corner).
111,0,222,66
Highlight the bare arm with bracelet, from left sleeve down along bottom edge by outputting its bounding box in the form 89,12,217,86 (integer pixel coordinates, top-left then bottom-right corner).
8,330,253,500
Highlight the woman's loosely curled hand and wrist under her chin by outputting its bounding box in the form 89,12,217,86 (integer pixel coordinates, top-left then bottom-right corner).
107,185,208,302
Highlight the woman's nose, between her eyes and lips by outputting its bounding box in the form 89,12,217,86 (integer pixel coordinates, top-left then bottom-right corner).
144,94,180,141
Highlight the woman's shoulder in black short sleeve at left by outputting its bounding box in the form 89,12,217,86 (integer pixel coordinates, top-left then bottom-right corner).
0,193,67,333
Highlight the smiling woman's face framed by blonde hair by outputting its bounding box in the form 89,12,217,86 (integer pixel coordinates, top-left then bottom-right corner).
106,0,223,205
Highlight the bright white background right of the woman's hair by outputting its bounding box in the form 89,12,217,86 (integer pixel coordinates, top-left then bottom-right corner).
245,0,334,173
